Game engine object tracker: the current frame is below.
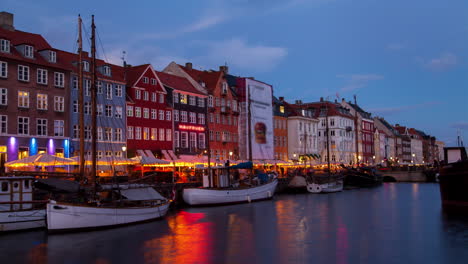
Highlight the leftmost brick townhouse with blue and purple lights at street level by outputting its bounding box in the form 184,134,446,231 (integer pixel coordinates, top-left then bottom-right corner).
0,12,71,172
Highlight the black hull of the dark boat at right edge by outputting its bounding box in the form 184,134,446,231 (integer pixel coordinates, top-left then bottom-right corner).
439,161,468,214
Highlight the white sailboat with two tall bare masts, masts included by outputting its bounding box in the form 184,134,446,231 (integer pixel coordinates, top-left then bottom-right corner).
47,16,171,231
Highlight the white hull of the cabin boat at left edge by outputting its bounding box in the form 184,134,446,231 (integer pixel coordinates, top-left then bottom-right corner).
0,209,46,232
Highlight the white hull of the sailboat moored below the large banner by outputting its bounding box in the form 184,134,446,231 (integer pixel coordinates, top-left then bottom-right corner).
183,179,278,206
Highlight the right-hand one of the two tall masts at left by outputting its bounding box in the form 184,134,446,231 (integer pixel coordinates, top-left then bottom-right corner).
91,15,97,194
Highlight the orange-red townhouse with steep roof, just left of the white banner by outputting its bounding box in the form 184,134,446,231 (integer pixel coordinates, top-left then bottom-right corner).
164,63,239,162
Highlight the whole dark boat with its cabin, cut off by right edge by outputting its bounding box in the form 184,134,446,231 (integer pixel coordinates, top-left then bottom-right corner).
439,147,468,214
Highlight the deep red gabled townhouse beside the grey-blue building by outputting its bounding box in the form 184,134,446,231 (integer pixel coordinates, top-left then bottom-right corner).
126,64,173,157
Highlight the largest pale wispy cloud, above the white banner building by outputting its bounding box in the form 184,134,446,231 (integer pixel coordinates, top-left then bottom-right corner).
196,38,288,72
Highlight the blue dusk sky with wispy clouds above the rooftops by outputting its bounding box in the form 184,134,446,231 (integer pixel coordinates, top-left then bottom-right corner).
1,0,468,146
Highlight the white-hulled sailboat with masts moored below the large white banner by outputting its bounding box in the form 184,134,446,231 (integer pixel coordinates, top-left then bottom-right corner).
183,78,278,206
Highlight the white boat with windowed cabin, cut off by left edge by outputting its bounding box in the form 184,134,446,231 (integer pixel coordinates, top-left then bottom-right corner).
0,177,46,232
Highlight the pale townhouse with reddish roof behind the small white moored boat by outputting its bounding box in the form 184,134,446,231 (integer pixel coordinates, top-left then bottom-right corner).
295,98,356,164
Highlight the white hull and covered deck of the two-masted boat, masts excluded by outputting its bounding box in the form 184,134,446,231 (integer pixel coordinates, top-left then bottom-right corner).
47,187,171,231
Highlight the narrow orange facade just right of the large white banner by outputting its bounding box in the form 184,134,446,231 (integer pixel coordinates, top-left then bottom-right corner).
273,96,289,161
